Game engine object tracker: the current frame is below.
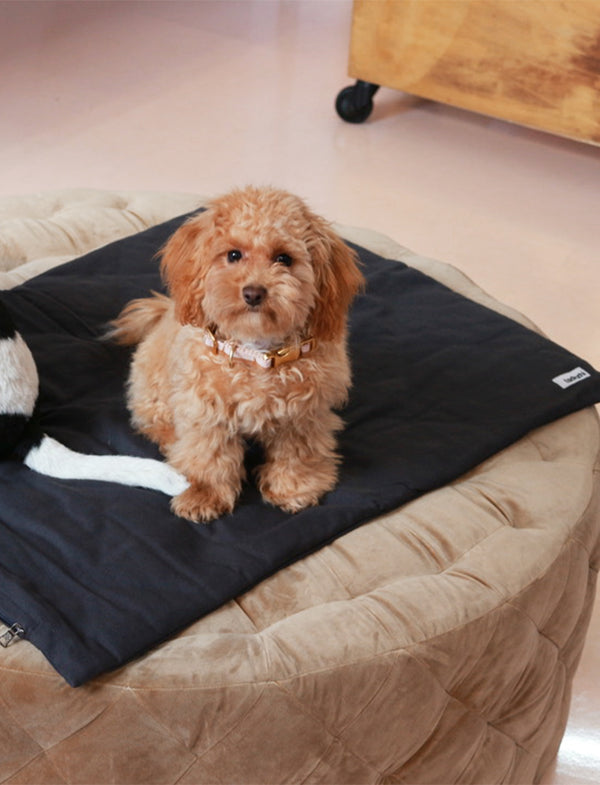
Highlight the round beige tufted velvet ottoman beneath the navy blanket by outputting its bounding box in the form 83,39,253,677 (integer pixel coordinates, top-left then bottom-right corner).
0,191,600,785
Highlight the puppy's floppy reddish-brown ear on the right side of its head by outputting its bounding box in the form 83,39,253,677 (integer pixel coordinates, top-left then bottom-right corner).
307,216,365,341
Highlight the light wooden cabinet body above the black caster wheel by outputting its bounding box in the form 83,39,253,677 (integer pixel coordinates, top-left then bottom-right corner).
342,0,600,144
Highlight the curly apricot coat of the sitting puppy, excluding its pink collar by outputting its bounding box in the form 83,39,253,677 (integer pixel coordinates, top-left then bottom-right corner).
112,187,363,521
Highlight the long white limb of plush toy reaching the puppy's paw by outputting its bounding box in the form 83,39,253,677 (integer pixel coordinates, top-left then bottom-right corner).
24,436,189,496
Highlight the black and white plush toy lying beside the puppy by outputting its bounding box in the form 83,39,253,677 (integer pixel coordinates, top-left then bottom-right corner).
0,301,188,496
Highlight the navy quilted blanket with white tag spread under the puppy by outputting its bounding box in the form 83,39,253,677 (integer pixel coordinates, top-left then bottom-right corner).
0,211,600,685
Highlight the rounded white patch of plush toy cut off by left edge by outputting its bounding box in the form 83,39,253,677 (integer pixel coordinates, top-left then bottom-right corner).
0,333,39,417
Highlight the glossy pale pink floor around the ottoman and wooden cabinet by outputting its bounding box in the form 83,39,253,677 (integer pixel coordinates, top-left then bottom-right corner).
0,0,600,785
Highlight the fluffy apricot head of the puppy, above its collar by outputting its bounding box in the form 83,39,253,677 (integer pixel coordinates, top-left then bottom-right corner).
161,188,364,345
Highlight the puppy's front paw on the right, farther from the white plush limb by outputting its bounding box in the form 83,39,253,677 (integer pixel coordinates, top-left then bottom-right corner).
258,464,337,512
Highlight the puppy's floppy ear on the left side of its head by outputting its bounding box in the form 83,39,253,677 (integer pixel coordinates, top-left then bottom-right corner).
160,212,212,327
